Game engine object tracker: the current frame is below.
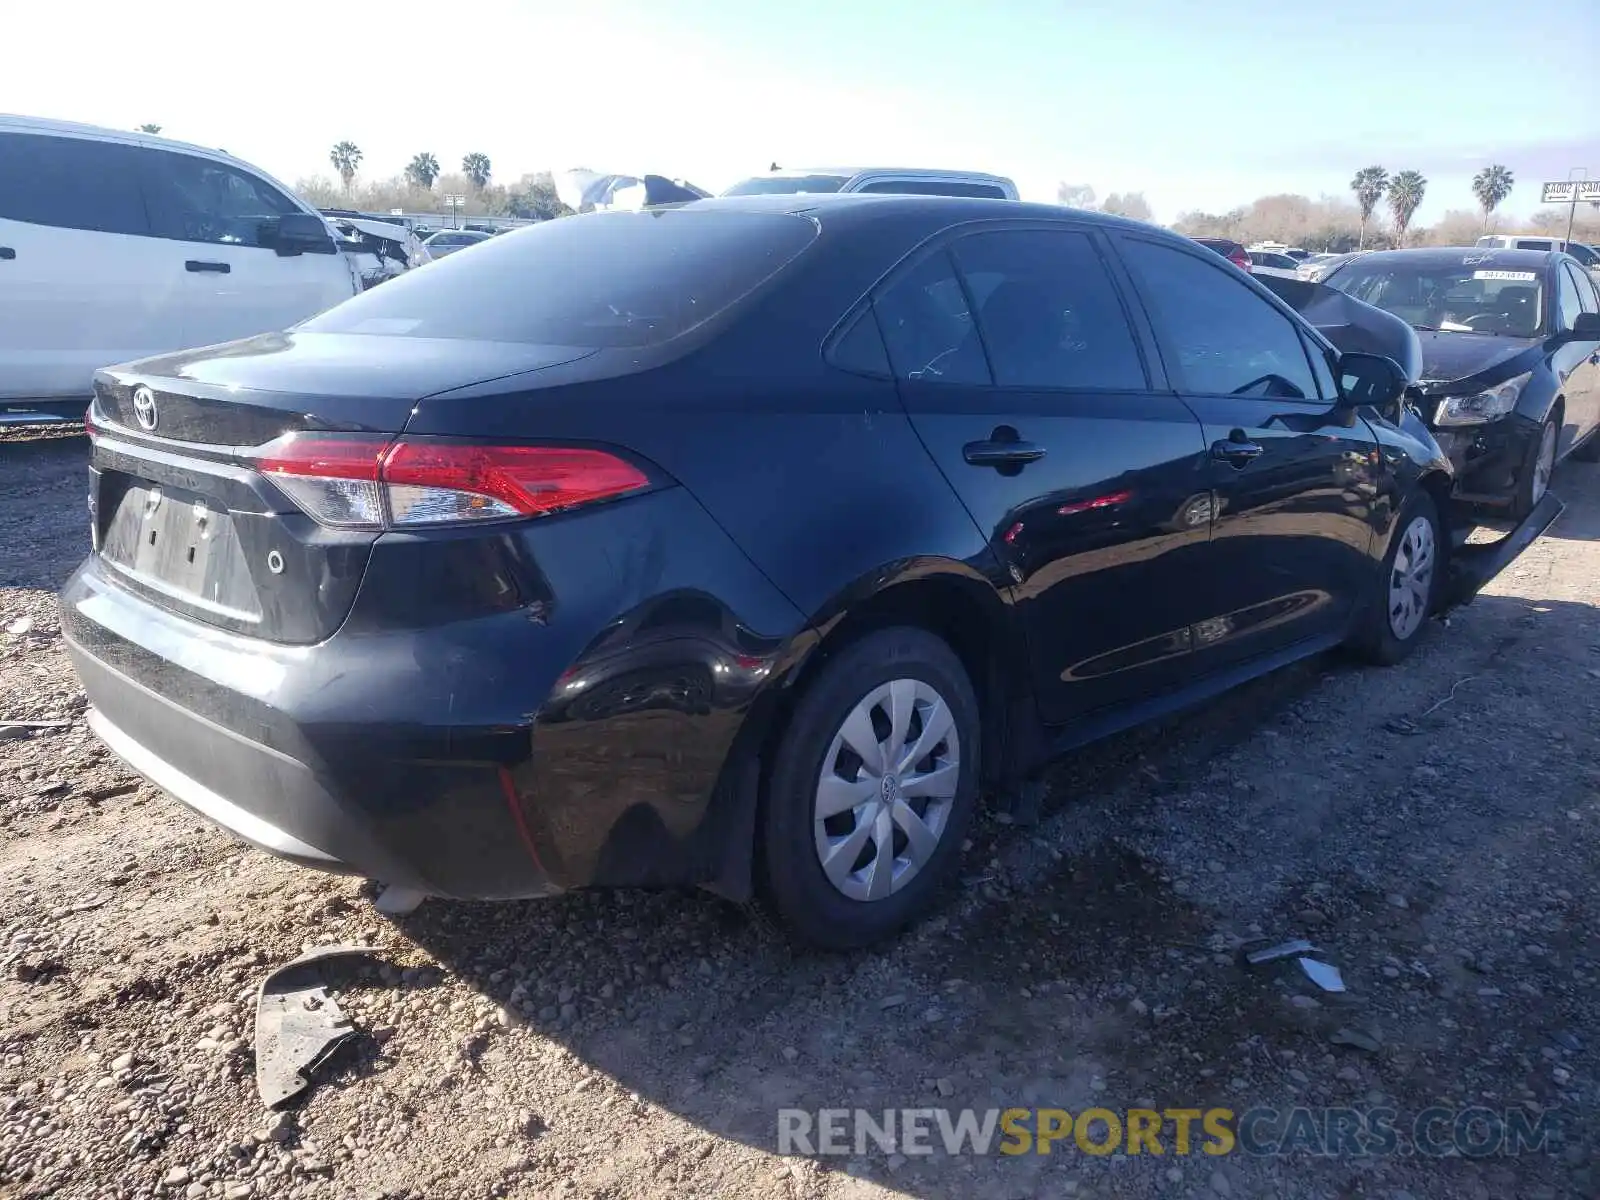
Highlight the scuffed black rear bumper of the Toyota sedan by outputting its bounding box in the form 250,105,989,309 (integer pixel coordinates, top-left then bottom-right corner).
61,488,803,899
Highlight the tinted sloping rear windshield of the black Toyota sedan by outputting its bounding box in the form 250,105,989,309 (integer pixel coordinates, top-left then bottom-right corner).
299,208,818,349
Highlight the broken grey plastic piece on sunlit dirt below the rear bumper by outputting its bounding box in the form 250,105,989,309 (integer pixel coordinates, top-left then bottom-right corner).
256,946,373,1109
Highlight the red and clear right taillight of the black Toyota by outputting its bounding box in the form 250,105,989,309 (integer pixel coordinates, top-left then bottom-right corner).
256,434,650,530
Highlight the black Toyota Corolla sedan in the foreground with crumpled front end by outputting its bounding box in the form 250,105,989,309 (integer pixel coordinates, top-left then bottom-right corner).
61,197,1558,946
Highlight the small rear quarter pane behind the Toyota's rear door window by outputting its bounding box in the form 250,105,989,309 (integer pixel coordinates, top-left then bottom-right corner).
874,250,990,386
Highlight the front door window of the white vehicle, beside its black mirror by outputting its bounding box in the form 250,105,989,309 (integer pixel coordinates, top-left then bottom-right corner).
139,150,301,246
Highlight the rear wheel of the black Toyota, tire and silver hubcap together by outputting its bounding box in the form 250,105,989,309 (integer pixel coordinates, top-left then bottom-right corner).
760,627,979,949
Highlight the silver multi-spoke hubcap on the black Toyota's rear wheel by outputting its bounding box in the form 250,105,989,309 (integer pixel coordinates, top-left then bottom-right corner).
813,678,962,901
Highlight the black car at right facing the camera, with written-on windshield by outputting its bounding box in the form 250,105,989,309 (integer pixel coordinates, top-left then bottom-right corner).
1325,248,1600,515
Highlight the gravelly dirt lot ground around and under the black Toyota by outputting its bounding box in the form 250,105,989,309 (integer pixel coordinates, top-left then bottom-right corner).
9,434,1600,1200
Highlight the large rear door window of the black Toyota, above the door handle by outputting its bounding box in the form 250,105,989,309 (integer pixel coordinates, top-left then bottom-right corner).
952,229,1147,390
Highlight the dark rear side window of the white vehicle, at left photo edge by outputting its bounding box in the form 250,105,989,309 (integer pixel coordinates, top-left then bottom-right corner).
0,133,150,237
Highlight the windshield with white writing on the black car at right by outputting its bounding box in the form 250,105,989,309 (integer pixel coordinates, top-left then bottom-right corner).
1326,254,1544,338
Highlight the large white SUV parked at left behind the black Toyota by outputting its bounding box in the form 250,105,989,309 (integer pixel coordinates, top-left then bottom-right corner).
0,115,362,416
